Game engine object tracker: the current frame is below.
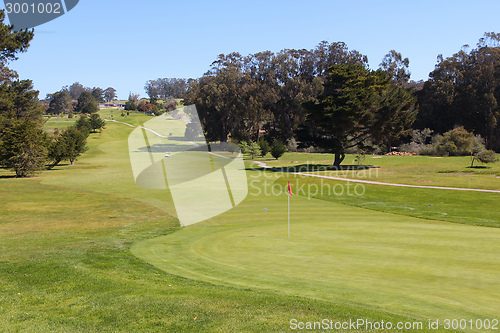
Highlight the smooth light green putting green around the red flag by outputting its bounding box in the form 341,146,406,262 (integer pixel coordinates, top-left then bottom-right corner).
133,167,500,320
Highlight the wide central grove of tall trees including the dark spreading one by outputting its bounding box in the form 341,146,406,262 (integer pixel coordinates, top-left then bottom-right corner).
184,42,415,164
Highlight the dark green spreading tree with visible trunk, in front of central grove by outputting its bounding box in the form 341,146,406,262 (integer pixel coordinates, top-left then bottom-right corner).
298,65,416,167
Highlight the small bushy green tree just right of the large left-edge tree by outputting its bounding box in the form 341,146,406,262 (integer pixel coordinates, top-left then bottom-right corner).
48,126,88,170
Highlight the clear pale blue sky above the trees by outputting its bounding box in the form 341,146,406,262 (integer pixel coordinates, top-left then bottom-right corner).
0,0,500,99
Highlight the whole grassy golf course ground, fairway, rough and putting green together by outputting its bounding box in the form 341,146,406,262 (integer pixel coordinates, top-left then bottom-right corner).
0,109,500,332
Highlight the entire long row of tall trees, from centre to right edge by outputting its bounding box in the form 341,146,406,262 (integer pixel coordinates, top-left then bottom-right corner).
183,33,500,165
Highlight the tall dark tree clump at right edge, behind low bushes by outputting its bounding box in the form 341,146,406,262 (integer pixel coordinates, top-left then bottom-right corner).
416,33,500,150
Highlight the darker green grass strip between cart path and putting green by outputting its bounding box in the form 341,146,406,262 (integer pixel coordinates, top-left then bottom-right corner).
274,172,500,228
